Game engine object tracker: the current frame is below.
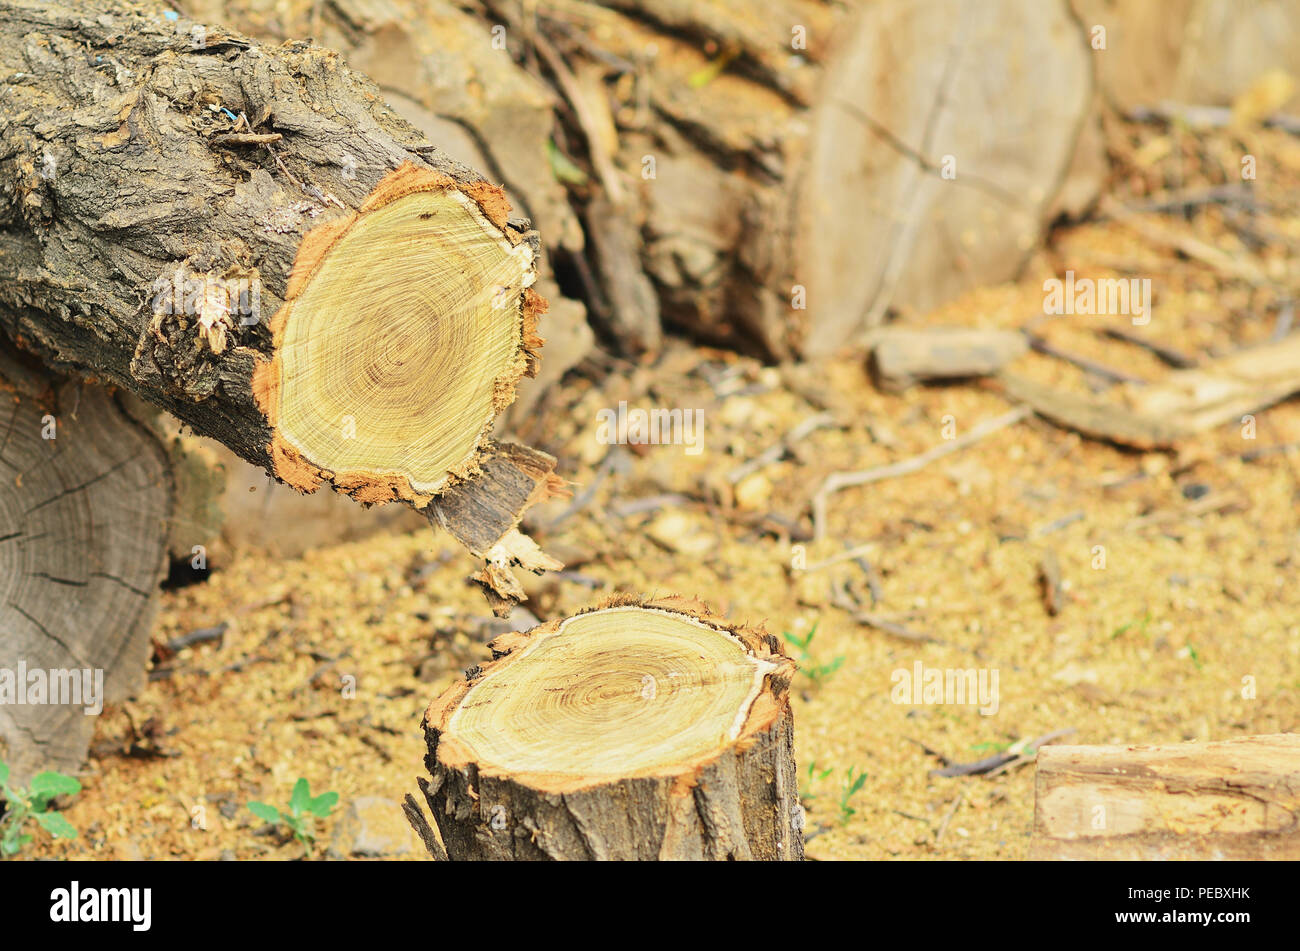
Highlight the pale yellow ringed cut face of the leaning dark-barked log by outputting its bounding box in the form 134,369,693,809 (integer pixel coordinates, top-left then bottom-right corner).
258,180,534,494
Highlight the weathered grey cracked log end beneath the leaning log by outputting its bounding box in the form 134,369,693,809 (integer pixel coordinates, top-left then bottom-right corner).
0,336,173,782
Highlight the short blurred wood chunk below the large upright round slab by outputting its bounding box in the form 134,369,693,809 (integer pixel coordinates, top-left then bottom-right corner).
870,327,1028,392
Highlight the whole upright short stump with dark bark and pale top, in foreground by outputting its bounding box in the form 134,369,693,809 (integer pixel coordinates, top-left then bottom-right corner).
408,598,803,860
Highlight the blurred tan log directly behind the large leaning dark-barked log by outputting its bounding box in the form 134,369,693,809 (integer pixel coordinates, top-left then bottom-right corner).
177,0,593,413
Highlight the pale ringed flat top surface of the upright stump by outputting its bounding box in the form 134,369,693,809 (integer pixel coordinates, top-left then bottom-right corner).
442,607,776,790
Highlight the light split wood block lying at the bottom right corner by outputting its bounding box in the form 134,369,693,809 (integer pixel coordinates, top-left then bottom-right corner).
1030,734,1300,861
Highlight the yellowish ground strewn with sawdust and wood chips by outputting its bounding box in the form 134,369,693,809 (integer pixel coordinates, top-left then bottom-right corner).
20,114,1300,859
